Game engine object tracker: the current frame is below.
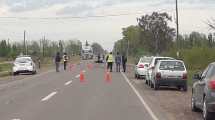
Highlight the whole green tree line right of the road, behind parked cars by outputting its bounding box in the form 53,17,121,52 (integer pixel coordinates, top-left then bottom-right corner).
114,12,215,56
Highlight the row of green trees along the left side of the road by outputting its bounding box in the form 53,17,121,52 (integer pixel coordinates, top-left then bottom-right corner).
0,39,82,59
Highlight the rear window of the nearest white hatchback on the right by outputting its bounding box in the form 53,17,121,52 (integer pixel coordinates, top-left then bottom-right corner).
159,61,185,71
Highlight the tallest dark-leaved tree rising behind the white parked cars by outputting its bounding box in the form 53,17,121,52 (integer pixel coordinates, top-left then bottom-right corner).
138,12,175,54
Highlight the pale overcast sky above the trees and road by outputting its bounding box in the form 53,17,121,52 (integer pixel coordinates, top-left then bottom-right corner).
0,0,215,50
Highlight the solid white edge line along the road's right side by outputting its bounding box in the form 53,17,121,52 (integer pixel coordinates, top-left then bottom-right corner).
121,72,159,120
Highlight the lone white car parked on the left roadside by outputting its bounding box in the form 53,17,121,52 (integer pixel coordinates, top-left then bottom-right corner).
13,56,37,75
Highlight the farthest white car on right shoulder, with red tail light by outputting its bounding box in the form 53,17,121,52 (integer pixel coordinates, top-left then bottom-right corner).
134,57,152,79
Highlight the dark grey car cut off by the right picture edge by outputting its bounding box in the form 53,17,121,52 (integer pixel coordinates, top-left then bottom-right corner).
191,63,215,120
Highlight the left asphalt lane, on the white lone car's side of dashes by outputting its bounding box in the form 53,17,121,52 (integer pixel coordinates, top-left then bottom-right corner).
0,63,82,120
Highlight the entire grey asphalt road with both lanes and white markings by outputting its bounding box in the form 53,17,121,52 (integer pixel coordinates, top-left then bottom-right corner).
0,61,165,120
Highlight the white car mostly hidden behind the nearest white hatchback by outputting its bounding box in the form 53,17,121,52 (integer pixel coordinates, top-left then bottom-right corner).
146,57,174,87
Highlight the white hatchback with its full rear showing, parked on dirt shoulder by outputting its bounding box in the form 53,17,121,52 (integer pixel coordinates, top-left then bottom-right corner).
152,60,187,91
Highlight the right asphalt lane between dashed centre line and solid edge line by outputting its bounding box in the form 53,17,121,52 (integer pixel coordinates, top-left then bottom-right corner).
23,62,152,120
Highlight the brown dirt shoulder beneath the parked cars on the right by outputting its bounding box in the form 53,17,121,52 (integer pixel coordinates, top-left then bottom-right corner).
126,66,202,120
